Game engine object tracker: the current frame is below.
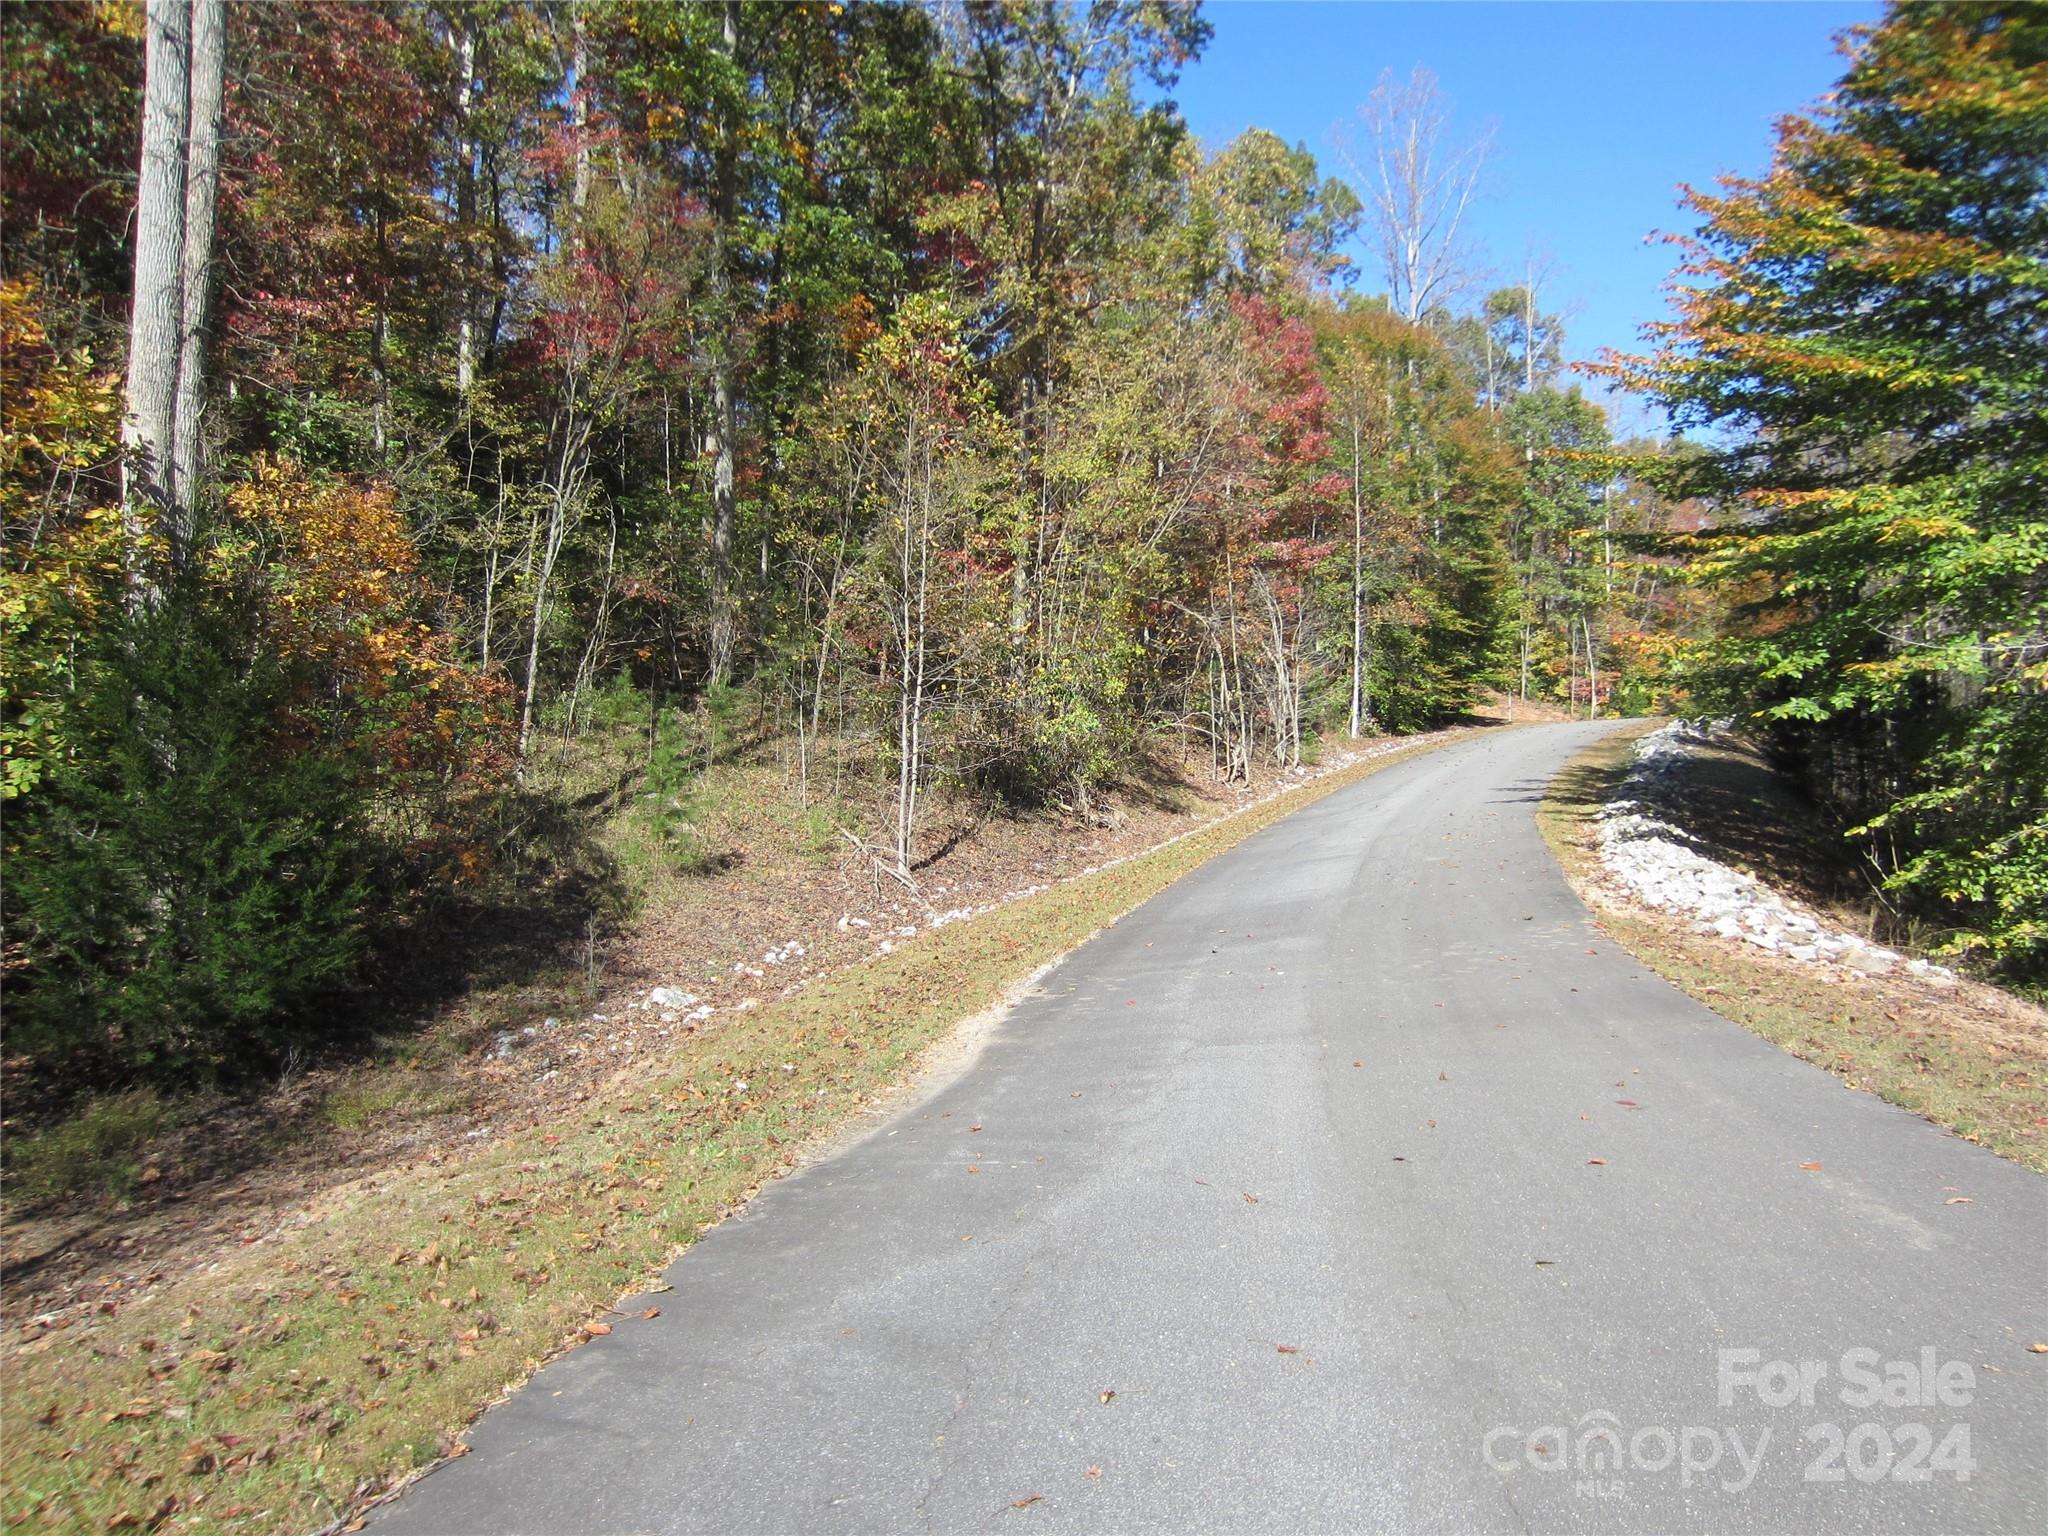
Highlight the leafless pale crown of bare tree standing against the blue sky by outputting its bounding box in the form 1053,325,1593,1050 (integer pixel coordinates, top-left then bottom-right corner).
1337,66,1493,324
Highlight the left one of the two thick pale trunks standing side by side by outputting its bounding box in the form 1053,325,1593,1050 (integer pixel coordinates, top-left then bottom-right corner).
121,0,193,604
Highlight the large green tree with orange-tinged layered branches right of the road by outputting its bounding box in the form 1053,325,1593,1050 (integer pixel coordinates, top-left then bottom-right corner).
1606,4,2048,965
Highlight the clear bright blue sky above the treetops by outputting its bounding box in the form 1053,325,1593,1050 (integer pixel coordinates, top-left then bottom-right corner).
1174,0,1880,434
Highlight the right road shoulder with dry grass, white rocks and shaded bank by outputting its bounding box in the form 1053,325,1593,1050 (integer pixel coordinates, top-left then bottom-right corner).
1538,721,2048,1174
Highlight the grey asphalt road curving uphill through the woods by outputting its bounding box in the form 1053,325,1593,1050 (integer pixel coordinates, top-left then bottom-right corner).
377,725,2048,1536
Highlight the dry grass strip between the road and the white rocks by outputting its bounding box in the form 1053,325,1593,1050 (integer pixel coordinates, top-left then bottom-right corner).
1536,723,2048,1174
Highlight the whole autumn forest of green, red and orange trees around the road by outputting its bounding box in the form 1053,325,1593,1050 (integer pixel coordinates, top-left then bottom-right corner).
0,0,2048,1092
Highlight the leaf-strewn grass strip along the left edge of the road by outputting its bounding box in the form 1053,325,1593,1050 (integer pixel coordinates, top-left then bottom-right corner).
0,731,1470,1532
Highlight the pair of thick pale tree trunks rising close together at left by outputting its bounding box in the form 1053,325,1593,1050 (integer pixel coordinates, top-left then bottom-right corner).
121,0,227,602
